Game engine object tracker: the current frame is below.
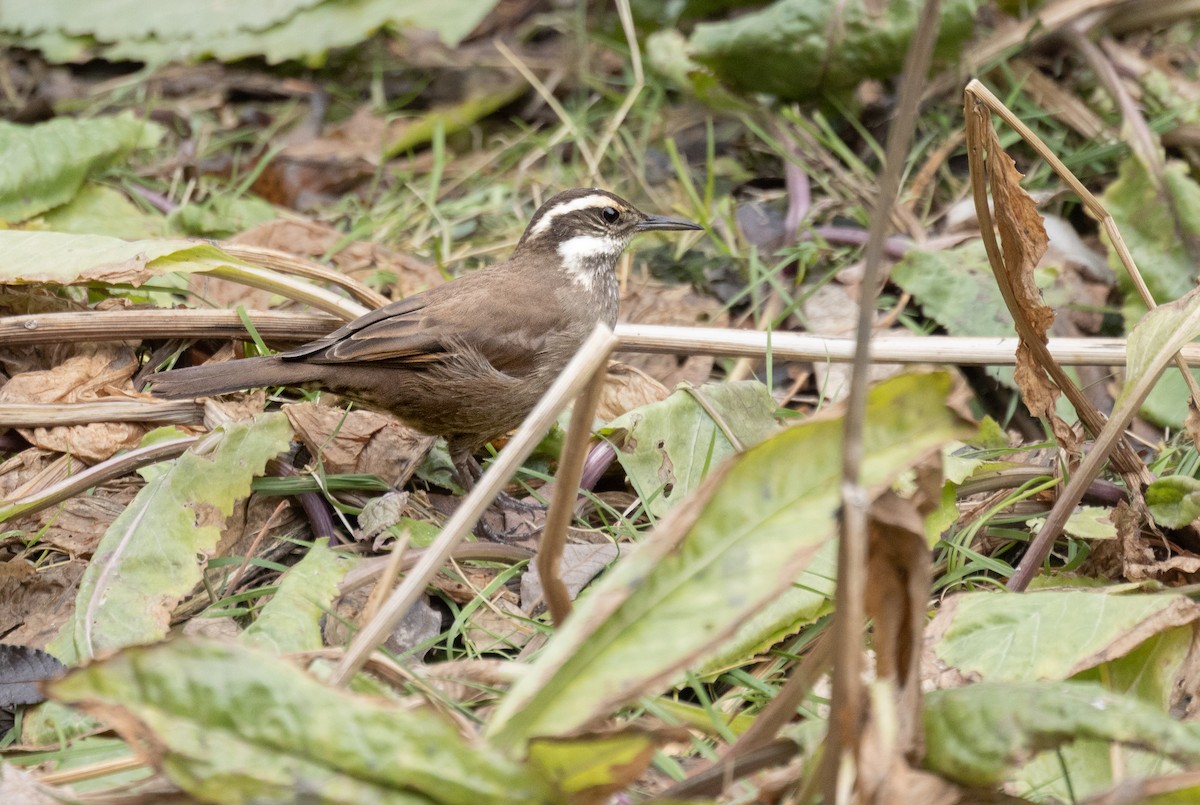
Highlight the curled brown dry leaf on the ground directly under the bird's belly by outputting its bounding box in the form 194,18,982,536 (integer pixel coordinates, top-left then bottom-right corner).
283,403,434,488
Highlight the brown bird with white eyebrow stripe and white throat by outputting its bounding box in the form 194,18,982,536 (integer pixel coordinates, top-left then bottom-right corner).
150,188,701,485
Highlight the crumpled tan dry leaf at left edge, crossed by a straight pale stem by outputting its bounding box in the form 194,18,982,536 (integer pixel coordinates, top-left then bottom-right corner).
0,343,146,462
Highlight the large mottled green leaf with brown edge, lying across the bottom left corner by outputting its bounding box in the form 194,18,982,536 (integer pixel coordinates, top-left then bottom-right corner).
50,638,554,805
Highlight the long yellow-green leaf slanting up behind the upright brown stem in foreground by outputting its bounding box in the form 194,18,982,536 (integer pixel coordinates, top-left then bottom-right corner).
488,373,966,745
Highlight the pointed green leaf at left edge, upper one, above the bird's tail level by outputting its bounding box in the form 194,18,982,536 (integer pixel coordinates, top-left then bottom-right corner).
0,111,162,223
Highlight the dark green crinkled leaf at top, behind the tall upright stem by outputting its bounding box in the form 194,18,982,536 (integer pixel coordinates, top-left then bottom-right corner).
691,0,977,101
